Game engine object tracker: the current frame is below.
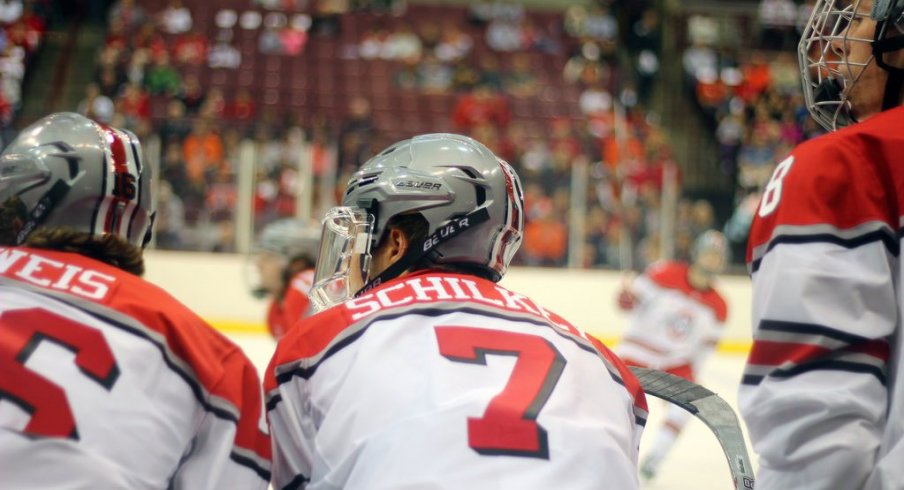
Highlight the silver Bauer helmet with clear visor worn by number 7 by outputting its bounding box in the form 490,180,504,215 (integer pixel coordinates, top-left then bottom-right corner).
311,133,524,309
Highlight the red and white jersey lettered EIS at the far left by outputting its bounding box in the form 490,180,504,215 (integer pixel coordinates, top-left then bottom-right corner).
0,247,270,490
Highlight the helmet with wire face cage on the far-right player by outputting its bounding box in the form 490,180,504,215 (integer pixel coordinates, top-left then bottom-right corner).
798,0,904,131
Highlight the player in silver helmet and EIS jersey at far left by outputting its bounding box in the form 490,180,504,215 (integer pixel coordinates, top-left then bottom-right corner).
0,113,270,490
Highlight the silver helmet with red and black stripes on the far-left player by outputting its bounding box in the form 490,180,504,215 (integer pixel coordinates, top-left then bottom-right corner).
0,113,154,247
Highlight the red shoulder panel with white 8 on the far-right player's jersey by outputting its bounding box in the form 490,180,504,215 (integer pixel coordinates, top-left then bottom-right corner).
747,108,904,263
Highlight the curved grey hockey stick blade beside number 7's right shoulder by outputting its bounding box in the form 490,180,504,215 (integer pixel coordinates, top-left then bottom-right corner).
630,366,754,490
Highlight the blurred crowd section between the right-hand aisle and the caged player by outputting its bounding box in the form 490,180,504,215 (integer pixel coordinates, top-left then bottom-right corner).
682,0,823,261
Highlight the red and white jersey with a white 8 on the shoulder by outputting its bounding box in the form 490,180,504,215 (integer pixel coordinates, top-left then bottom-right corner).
739,108,904,490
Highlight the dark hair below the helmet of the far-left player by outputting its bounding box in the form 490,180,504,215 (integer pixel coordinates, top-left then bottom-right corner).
22,228,144,276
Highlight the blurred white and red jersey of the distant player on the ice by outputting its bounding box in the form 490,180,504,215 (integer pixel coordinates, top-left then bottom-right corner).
617,261,728,381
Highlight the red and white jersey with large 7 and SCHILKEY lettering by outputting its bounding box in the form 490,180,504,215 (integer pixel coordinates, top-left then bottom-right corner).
264,272,647,490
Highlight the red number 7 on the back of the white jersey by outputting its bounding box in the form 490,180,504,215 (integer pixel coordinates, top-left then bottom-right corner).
436,326,565,459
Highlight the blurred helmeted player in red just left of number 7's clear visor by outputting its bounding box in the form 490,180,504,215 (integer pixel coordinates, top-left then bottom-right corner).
257,218,320,341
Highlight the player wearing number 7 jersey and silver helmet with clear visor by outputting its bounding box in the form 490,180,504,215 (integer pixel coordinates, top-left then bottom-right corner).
265,134,646,490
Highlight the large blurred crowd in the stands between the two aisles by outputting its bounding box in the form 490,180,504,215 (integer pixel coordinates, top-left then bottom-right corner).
60,0,740,269
